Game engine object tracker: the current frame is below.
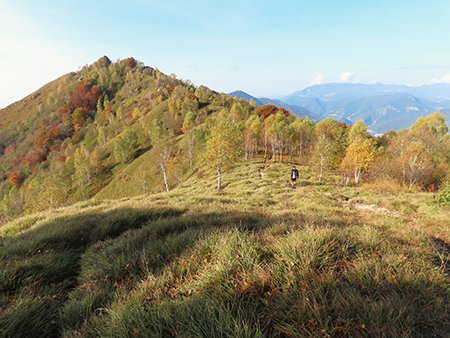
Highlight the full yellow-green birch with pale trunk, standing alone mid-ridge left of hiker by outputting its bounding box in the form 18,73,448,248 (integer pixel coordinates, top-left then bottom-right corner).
202,114,242,192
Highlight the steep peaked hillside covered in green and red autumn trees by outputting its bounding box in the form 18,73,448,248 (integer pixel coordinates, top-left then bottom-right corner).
0,56,260,222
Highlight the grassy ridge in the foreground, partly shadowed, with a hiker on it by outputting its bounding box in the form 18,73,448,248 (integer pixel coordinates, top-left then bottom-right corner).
0,158,450,337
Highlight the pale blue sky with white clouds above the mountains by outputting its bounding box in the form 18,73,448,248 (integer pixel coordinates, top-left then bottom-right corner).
0,0,450,108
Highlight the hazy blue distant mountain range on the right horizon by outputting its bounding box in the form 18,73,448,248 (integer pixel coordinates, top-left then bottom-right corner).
229,83,450,134
